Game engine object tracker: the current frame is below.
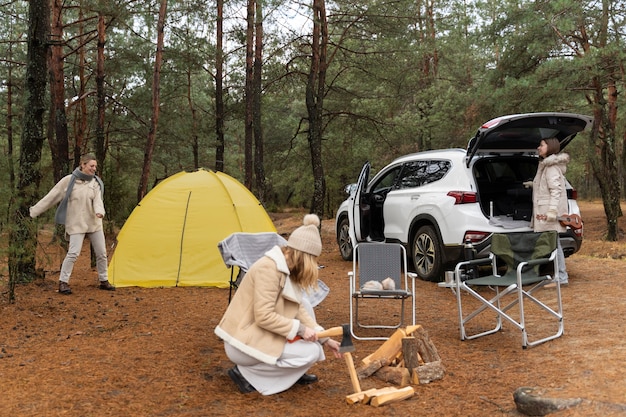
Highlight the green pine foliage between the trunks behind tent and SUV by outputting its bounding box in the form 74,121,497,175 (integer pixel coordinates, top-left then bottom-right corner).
0,0,626,234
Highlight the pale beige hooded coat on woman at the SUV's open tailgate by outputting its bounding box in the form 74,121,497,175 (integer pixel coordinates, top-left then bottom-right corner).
531,153,569,233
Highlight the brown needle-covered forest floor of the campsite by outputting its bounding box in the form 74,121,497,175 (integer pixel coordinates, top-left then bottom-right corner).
0,201,626,417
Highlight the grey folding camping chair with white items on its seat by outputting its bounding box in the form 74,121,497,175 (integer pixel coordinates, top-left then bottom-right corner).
348,242,417,340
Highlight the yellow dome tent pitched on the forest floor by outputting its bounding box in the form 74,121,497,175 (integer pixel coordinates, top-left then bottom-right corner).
109,169,276,288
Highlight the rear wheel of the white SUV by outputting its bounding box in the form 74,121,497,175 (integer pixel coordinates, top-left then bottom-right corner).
411,226,442,282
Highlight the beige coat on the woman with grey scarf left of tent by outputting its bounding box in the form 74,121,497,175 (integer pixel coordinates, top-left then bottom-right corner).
30,174,105,235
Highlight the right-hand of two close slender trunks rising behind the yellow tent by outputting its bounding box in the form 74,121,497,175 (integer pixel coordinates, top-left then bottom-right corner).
253,1,265,203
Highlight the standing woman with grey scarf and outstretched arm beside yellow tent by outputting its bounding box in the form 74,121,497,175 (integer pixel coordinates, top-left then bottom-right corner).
30,154,115,295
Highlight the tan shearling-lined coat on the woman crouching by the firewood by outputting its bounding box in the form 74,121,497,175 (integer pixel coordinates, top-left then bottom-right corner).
215,246,322,365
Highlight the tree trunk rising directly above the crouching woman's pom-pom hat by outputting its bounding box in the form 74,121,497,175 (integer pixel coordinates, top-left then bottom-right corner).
306,0,328,217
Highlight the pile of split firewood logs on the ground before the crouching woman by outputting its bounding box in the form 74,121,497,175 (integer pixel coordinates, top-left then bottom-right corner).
346,325,445,407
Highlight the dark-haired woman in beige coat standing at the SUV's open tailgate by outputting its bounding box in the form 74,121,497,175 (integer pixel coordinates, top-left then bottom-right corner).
531,138,569,285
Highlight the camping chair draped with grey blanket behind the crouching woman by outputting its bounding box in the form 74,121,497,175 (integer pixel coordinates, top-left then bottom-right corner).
217,232,287,303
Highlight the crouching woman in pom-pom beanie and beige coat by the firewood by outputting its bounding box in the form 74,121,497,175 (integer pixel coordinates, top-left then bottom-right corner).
215,214,341,395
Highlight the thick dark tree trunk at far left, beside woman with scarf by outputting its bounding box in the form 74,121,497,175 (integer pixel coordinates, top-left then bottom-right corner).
8,0,50,302
